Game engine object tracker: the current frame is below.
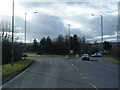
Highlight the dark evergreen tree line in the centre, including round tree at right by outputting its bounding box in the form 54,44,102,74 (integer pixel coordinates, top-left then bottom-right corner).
32,34,112,55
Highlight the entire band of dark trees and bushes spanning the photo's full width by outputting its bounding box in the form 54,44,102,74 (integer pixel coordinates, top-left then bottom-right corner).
0,20,120,64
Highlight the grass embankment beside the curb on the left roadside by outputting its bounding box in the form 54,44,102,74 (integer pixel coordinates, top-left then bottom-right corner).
1,59,33,82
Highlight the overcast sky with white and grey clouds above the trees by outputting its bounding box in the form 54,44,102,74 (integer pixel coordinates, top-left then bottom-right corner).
0,0,118,42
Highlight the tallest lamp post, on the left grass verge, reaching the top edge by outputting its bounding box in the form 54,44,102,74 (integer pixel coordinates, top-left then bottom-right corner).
11,0,14,66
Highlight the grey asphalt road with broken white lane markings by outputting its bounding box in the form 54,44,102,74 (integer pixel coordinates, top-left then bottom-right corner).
3,57,118,88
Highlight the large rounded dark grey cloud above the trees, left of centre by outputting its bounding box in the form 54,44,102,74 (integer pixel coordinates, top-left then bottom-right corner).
27,14,65,37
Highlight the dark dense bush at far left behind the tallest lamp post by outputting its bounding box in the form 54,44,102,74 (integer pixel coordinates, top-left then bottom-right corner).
2,40,23,64
